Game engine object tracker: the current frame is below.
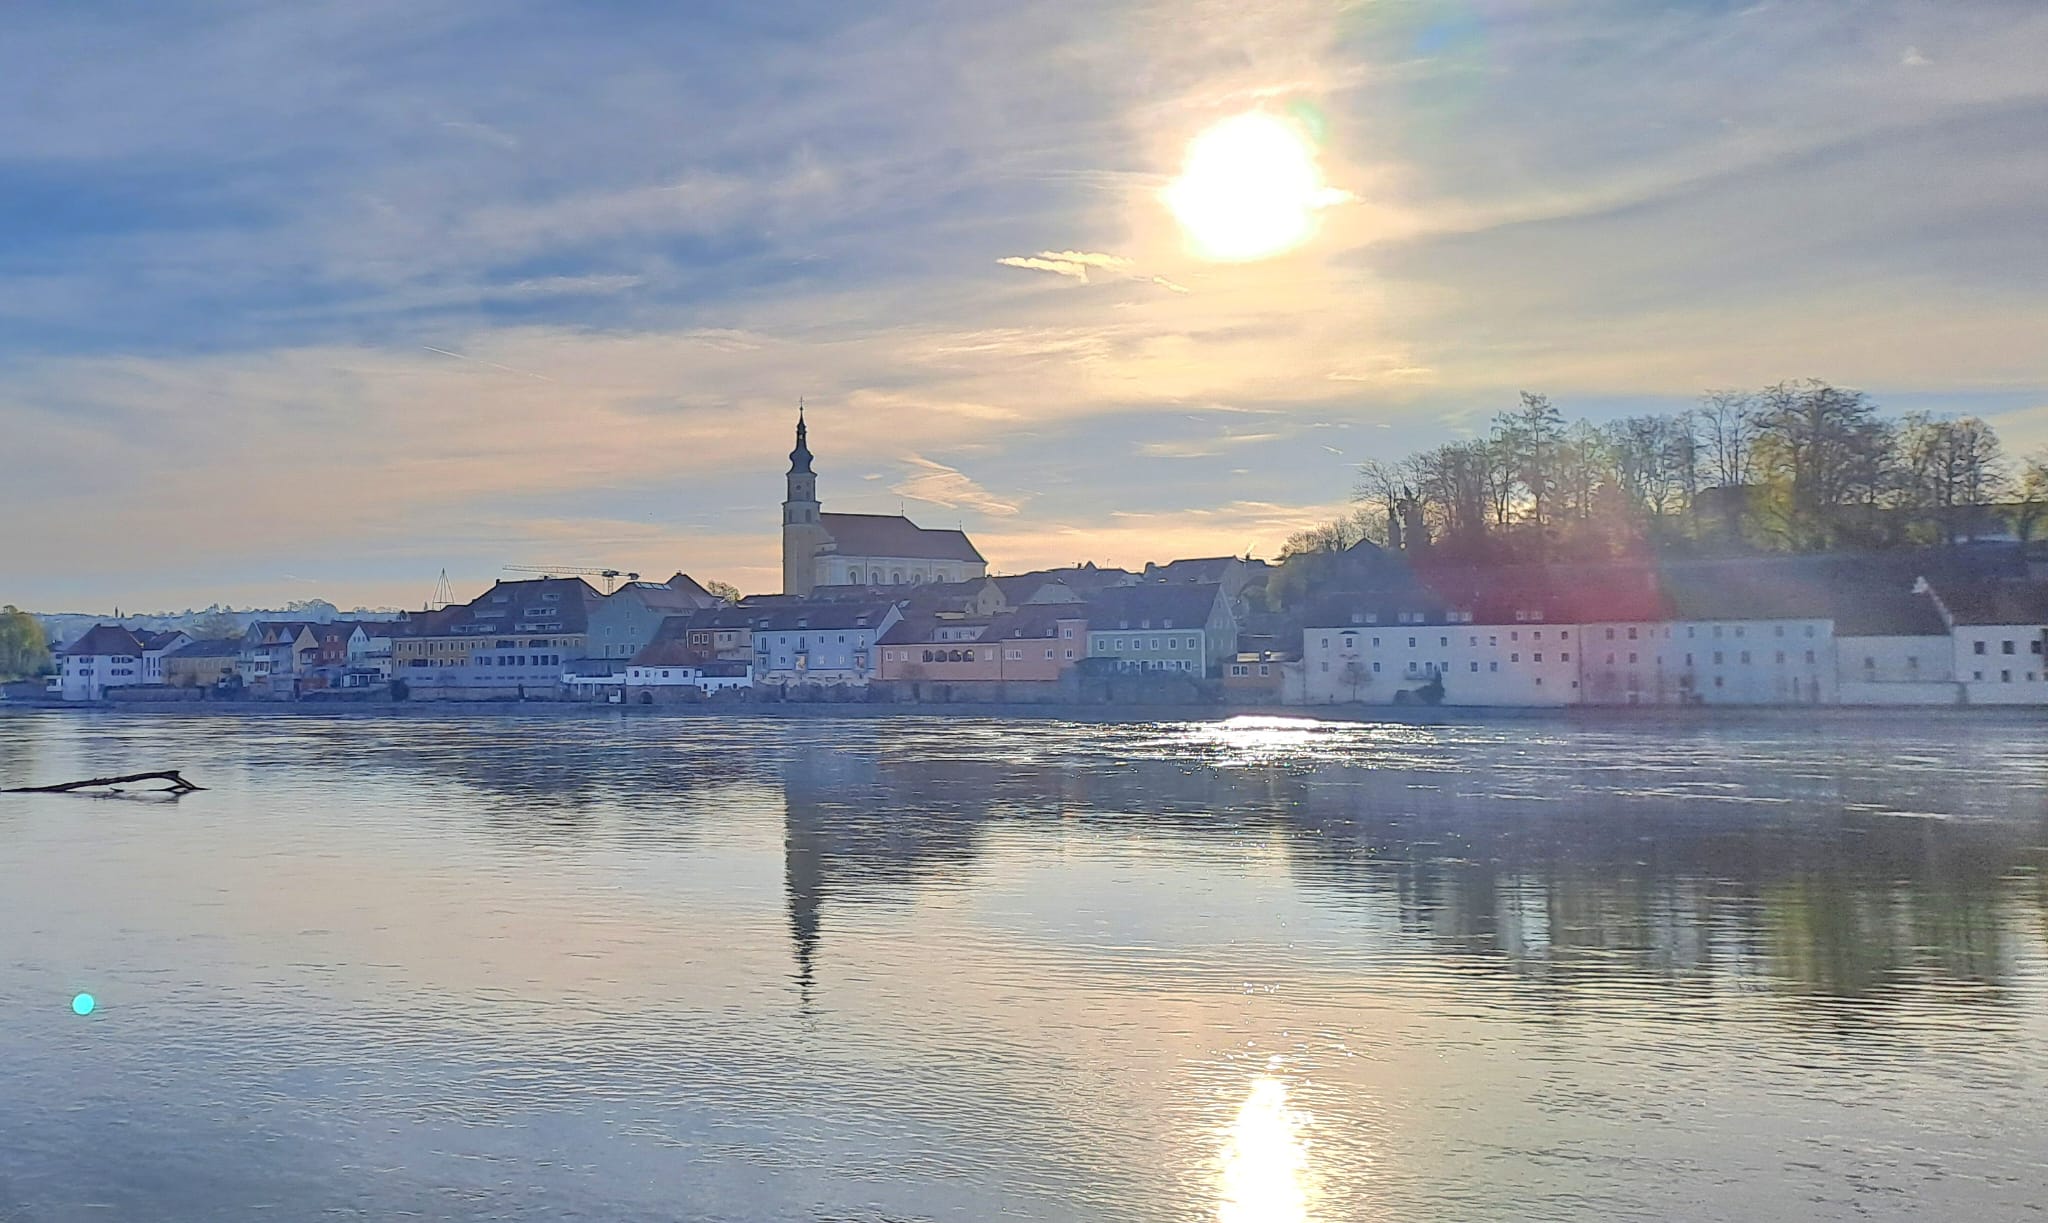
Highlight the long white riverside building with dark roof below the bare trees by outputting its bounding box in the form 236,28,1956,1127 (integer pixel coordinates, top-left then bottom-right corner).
1286,561,2048,707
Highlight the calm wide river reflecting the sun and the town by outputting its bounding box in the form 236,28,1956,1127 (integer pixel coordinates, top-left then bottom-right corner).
0,713,2048,1223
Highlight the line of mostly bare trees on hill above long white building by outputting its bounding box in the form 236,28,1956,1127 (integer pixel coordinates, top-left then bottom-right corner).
1282,381,2048,563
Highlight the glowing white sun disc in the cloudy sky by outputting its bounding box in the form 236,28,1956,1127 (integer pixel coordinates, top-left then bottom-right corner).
1161,111,1350,262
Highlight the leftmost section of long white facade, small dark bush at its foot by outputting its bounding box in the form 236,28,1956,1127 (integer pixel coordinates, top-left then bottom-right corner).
1282,621,1579,707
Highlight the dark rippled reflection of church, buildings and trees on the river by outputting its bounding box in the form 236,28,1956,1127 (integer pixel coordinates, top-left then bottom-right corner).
782,723,2048,1022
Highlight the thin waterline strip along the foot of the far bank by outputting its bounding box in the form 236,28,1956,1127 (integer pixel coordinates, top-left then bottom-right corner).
0,701,2048,725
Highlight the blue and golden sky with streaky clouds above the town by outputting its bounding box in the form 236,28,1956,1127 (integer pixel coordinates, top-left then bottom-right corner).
0,0,2048,613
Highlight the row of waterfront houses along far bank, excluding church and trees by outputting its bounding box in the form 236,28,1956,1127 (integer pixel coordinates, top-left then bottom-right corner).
51,545,2048,707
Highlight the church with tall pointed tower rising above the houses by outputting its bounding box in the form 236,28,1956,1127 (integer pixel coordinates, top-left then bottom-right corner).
782,408,989,596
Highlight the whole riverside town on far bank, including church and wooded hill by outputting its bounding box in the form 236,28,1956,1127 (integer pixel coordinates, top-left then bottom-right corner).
6,383,2048,709
